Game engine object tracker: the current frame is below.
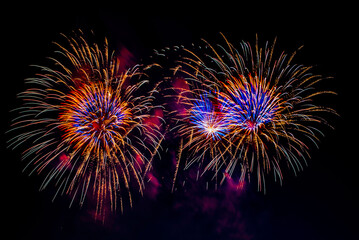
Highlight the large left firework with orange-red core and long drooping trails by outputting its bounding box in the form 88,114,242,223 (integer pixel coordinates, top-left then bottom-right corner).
9,31,162,216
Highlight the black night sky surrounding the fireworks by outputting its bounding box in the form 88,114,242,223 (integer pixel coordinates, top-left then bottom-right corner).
1,1,359,240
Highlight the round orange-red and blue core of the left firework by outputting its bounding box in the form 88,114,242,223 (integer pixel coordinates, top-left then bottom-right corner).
59,84,130,150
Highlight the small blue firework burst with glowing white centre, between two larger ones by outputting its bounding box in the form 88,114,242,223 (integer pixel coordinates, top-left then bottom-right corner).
177,88,229,181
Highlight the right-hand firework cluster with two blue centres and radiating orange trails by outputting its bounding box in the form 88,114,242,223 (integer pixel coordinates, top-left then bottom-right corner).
170,36,336,189
